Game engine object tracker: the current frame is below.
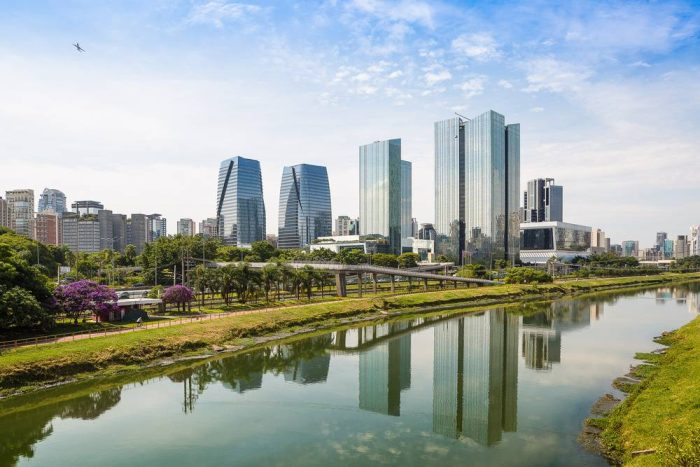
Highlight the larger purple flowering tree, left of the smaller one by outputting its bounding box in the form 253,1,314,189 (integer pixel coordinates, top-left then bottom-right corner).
54,280,119,324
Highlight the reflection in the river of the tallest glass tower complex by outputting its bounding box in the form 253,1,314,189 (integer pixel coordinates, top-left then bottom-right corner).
433,309,519,445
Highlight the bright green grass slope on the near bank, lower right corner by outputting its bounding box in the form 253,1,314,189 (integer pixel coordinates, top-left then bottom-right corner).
603,318,700,466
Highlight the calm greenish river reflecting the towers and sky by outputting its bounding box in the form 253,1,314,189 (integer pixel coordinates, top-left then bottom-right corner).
0,284,700,466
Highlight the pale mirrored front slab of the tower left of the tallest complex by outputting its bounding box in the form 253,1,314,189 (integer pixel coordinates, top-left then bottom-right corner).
360,139,401,254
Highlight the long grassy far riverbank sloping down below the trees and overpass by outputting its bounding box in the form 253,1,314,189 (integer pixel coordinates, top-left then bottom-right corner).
0,274,700,396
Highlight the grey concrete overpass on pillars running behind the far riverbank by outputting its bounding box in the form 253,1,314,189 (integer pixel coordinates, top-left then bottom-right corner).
210,261,502,297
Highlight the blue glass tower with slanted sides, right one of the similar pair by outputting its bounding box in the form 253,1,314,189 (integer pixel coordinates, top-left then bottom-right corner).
277,164,333,248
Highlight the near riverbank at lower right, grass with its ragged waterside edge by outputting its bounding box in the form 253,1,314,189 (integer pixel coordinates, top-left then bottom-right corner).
587,317,700,466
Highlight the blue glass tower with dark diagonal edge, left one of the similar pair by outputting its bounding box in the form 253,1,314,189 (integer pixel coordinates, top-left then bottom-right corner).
216,156,266,246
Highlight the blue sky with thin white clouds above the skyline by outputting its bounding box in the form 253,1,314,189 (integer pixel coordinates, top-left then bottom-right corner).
0,0,700,246
